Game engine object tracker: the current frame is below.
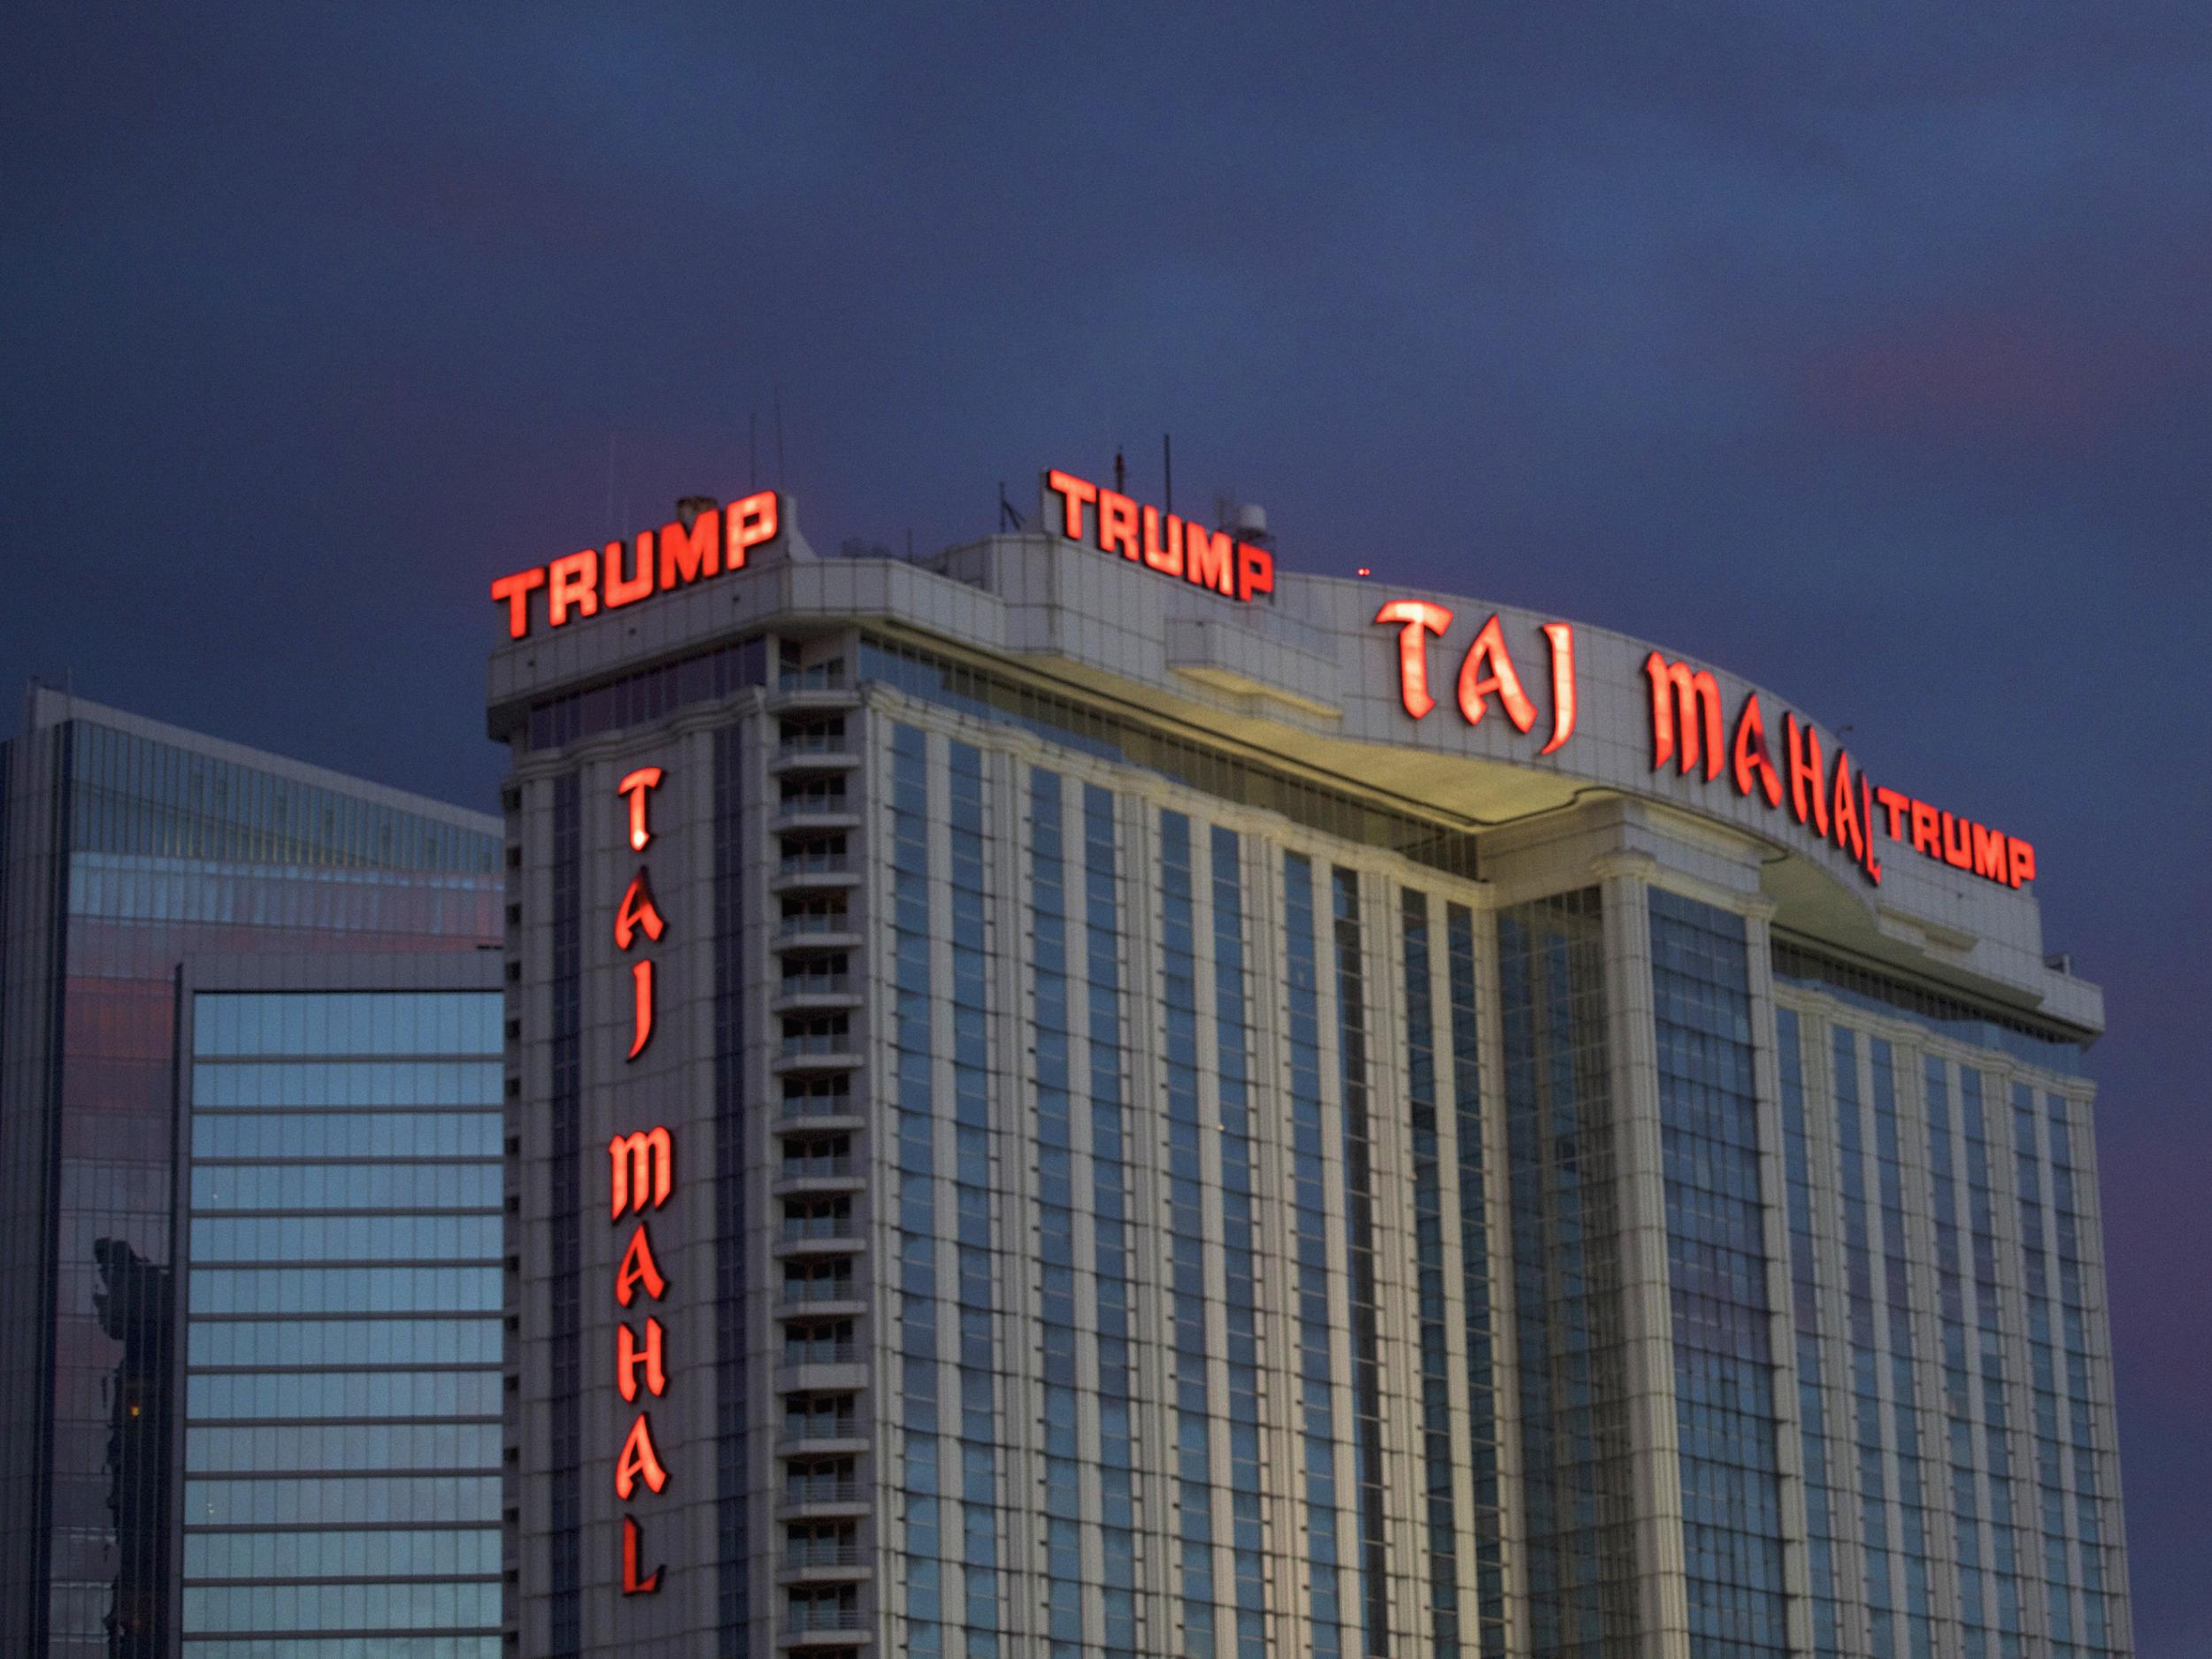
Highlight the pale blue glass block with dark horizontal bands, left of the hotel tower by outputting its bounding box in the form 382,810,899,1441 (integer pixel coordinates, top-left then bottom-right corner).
175,969,504,1659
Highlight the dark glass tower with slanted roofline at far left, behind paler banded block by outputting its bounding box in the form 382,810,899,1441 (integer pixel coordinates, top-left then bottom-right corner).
0,688,500,1659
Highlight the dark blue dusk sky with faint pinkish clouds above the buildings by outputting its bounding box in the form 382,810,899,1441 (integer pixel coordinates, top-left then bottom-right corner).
0,0,2212,1655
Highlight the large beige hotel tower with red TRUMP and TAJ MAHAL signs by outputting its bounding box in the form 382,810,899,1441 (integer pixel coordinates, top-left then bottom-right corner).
489,472,2132,1659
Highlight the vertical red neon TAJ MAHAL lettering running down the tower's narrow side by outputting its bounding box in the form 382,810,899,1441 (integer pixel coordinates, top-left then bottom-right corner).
606,774,677,1595
